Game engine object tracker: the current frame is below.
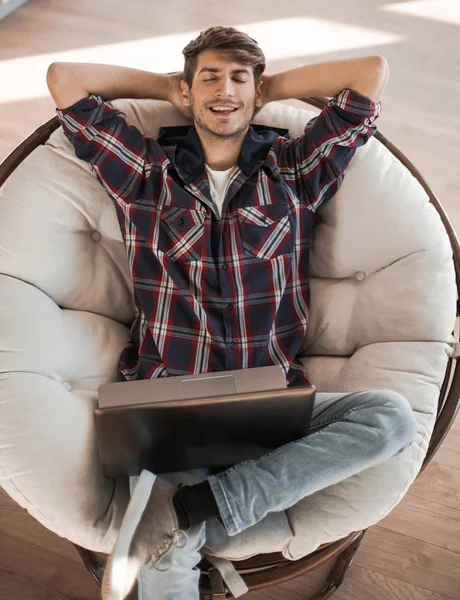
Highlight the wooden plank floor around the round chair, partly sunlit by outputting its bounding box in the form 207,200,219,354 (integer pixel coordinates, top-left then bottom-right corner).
0,0,460,600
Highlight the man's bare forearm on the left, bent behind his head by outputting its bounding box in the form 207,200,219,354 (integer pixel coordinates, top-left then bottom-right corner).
46,63,171,108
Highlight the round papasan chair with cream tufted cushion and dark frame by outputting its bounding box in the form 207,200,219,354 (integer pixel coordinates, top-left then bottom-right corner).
0,91,460,600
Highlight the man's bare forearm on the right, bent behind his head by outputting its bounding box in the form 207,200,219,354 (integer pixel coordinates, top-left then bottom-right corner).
264,56,388,102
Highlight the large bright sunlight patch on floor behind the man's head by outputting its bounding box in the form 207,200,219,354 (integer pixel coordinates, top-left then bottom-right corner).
0,17,401,104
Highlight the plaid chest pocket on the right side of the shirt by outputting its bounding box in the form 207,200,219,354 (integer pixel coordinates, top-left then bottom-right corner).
238,202,293,259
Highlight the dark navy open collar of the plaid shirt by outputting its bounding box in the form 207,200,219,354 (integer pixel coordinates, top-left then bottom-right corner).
157,125,289,184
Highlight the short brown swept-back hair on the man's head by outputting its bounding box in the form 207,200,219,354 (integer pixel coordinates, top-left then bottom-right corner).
182,27,265,87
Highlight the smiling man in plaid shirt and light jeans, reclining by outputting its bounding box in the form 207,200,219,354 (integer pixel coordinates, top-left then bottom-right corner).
47,27,416,600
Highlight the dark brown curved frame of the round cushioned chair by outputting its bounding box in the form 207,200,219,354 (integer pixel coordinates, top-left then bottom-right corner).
0,97,460,600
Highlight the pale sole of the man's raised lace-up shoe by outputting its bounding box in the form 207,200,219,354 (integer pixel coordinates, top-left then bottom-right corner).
101,470,156,600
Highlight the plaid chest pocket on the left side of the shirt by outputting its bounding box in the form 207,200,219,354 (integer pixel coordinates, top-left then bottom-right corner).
158,206,206,262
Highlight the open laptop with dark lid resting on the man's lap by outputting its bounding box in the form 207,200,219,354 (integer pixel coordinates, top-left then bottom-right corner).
95,365,316,478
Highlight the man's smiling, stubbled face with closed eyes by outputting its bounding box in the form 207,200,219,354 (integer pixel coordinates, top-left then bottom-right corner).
181,50,262,138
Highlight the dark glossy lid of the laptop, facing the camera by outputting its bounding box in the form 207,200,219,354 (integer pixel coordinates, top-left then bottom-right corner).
95,370,316,477
